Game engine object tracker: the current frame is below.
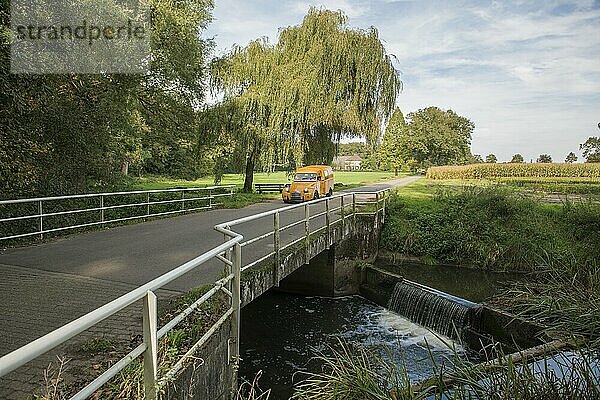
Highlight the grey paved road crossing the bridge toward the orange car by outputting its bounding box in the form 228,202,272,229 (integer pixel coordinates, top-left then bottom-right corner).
0,177,419,399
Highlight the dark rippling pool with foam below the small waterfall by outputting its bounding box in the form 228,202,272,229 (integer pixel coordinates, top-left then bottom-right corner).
240,292,464,400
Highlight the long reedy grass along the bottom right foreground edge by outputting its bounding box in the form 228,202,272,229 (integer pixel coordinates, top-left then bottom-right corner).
293,345,600,400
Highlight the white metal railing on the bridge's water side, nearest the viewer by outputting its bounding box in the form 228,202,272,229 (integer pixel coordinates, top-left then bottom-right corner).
0,189,387,400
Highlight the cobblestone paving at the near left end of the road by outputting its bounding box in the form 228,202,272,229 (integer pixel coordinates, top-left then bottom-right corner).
0,264,178,400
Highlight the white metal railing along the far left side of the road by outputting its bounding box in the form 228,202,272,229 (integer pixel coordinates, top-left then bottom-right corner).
0,185,235,241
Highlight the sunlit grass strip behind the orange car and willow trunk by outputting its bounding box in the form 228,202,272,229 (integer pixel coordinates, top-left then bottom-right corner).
131,171,405,190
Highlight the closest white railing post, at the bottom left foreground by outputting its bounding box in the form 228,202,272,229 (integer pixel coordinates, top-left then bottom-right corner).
143,291,158,400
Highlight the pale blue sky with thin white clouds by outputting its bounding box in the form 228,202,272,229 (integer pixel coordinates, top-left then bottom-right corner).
204,0,600,162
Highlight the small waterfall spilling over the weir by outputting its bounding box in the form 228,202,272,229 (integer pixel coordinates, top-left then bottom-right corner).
388,279,479,339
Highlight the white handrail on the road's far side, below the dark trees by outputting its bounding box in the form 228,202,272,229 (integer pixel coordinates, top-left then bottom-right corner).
0,185,235,241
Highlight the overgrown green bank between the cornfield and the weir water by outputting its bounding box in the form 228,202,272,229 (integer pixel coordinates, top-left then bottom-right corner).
381,187,600,271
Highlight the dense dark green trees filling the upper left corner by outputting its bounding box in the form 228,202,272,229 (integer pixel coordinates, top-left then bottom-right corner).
0,0,212,197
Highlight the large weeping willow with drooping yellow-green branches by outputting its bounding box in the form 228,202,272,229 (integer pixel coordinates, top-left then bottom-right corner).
211,8,402,191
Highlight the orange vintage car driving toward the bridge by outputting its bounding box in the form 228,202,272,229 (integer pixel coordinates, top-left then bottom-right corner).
281,165,333,203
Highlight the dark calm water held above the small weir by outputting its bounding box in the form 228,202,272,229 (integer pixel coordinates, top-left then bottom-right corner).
375,261,522,303
